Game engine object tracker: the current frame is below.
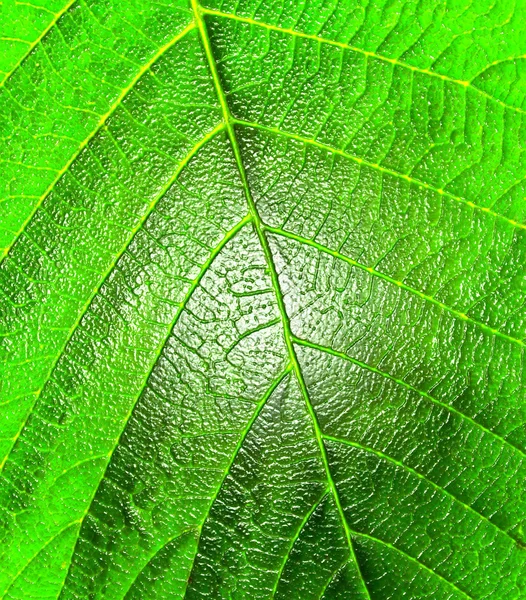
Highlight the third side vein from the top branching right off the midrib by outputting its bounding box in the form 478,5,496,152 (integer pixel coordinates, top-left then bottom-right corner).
263,225,526,347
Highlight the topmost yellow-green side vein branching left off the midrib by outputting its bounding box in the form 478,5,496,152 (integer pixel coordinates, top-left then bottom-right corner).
0,23,195,264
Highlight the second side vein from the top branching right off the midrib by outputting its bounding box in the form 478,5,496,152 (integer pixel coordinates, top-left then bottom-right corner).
233,119,526,230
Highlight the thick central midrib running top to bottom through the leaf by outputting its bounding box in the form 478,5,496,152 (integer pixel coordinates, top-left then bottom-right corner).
191,0,371,600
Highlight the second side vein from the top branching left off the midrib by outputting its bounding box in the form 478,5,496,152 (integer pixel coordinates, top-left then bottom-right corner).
0,123,224,473
